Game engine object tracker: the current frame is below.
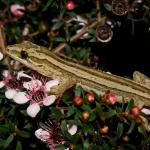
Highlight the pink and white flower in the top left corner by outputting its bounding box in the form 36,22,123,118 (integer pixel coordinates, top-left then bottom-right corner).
10,4,25,17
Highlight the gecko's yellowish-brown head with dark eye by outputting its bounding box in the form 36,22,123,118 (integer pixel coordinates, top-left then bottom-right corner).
7,41,40,65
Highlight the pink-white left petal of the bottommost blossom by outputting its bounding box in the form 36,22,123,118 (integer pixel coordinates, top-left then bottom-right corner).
35,128,50,142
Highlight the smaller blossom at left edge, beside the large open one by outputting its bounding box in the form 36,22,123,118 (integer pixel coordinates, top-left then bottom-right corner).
0,70,26,99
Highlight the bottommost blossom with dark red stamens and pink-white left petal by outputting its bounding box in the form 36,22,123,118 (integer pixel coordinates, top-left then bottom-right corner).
35,121,64,150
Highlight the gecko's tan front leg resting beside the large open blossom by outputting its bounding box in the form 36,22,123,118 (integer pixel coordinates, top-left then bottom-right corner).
50,75,77,97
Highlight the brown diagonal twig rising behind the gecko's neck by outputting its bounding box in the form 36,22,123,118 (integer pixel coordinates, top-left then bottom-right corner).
52,20,98,53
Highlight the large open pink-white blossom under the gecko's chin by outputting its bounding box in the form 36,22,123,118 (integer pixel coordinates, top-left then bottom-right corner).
13,72,59,117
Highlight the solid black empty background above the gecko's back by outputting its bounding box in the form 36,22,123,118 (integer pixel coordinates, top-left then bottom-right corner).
92,21,150,77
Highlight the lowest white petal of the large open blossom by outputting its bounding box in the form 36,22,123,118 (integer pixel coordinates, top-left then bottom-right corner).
27,103,40,118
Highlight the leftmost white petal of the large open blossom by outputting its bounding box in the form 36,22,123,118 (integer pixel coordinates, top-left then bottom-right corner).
13,92,29,104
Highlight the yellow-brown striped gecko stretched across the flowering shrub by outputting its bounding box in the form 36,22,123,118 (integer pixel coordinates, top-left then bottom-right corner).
6,41,150,107
